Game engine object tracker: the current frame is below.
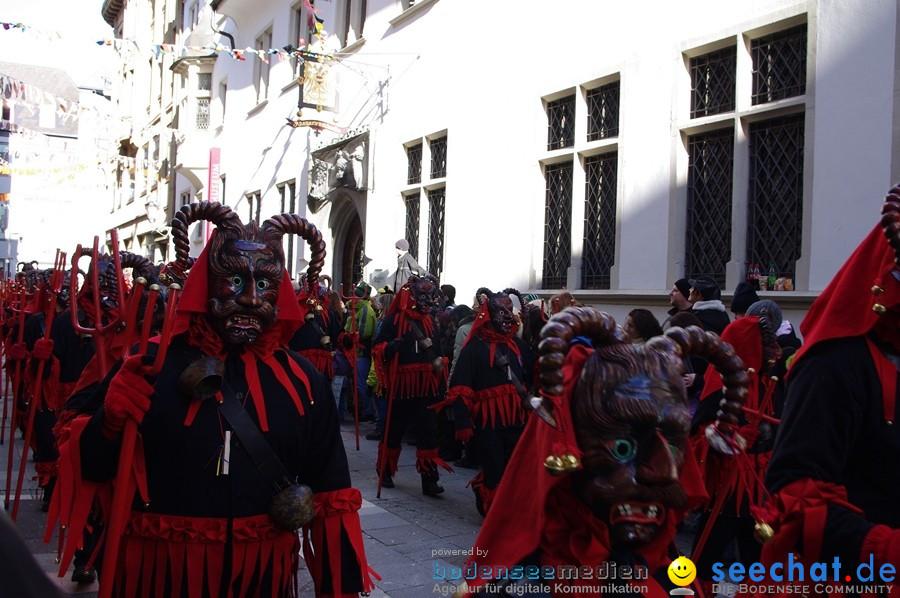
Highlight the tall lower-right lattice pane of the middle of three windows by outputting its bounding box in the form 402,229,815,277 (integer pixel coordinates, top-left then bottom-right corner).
581,152,619,289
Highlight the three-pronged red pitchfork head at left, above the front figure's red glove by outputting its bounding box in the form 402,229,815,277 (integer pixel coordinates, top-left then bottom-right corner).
69,229,125,376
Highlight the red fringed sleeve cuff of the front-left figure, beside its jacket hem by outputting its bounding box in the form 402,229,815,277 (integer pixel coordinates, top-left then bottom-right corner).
303,490,374,596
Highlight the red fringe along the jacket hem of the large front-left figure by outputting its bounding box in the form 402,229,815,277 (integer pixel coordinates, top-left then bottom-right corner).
115,513,300,598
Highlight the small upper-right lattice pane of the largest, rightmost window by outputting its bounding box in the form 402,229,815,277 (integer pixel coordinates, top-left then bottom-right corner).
750,23,806,106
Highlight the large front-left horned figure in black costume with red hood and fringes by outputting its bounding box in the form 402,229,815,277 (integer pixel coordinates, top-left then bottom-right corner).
70,202,374,597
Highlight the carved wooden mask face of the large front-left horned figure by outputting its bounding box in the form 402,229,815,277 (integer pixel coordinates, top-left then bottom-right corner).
208,234,284,345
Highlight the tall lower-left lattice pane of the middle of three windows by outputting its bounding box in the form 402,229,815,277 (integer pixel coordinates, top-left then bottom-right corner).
541,162,572,289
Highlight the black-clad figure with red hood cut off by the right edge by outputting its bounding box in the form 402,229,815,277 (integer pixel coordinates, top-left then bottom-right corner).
758,187,900,585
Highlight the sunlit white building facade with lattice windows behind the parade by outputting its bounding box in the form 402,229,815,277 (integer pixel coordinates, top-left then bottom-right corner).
102,0,900,322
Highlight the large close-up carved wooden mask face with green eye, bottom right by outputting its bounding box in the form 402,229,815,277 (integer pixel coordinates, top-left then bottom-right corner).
572,343,691,548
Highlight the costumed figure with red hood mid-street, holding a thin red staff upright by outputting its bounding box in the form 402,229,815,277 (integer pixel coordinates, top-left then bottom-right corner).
372,276,453,496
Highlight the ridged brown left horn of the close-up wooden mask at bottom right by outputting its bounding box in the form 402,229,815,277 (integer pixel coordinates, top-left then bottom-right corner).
538,307,624,396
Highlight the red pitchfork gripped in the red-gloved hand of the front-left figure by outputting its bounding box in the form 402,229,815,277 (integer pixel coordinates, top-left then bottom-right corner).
99,284,181,598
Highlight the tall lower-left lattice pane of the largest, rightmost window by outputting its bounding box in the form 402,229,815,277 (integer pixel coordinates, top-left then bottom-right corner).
684,129,734,286
